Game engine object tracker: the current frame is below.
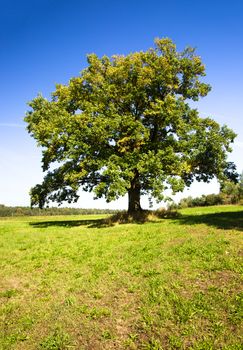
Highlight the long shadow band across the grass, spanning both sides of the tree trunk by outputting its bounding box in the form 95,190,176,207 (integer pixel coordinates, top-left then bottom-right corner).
30,210,243,231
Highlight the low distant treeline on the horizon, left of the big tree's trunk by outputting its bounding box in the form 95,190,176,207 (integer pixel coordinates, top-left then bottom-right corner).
0,204,118,217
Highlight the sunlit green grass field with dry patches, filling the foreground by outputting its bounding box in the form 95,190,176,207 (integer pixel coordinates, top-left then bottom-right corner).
0,206,243,350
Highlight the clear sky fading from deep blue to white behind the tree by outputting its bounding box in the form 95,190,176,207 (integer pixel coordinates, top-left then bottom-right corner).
0,0,243,208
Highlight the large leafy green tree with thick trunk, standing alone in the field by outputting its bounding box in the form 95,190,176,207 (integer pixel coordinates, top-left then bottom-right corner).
25,38,236,212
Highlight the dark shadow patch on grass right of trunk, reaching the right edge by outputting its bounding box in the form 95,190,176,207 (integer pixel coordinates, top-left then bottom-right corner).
176,210,243,231
